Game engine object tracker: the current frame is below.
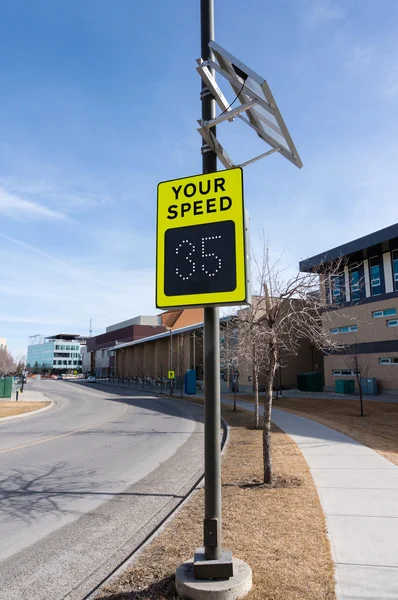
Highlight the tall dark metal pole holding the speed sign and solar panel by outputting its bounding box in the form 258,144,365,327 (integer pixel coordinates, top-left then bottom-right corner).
200,0,222,560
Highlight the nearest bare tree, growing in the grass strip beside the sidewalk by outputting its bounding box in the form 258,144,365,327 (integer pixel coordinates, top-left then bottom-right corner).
249,239,342,483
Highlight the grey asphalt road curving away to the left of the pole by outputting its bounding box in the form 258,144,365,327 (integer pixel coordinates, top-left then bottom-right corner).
0,381,203,600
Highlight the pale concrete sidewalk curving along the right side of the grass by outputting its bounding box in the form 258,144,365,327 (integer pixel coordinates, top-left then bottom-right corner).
223,398,398,600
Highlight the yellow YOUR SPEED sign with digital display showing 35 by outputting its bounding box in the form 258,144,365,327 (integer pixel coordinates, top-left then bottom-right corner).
156,168,248,308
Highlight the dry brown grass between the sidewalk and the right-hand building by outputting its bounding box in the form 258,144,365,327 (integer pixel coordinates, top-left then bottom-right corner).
274,397,398,465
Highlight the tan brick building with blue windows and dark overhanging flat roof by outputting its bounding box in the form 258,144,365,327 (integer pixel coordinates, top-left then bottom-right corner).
300,224,398,392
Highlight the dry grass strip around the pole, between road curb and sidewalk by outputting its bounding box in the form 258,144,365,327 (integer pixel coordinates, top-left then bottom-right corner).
98,408,335,600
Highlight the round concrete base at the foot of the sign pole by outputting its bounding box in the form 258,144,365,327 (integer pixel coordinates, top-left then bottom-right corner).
175,558,252,600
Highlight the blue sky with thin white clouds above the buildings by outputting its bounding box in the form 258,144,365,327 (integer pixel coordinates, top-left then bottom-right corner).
0,0,398,354
